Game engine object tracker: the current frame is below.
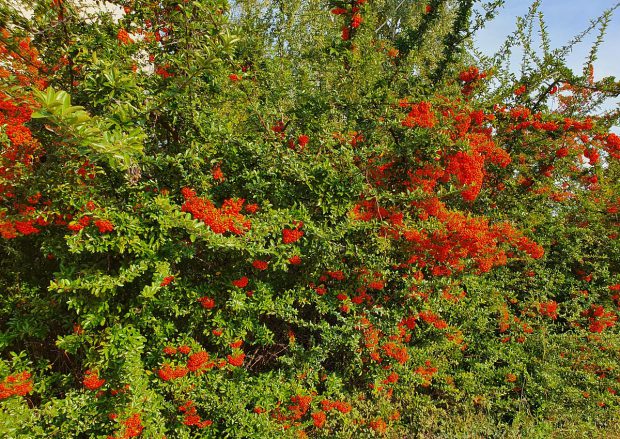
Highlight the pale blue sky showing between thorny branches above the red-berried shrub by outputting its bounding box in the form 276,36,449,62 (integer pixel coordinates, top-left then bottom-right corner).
476,0,620,79
